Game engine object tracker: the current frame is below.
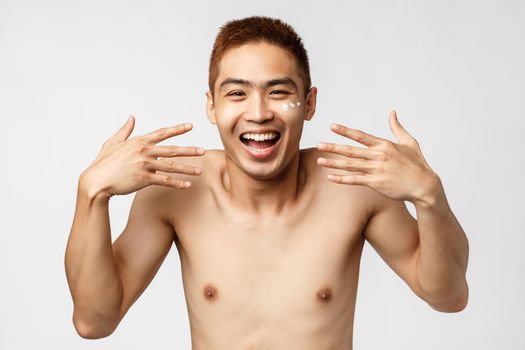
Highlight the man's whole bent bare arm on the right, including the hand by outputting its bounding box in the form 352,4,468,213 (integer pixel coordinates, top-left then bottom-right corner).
318,112,469,312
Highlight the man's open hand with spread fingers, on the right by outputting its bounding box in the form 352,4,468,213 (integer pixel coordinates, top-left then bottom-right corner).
317,111,441,202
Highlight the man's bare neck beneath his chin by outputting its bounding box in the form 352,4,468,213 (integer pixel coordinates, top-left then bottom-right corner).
223,150,306,216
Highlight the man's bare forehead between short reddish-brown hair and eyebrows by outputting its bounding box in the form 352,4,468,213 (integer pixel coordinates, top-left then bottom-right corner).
216,42,300,86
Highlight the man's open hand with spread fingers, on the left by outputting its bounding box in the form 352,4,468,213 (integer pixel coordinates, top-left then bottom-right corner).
81,116,205,198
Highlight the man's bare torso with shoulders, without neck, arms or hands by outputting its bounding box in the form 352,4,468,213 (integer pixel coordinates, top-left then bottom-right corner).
166,149,372,350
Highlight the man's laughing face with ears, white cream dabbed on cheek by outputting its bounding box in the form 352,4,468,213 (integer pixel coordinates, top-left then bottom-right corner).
206,42,317,179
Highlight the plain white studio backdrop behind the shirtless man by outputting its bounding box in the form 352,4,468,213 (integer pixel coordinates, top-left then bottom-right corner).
0,0,525,350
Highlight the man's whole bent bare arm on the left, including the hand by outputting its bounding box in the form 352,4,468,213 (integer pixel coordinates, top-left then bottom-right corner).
64,117,205,338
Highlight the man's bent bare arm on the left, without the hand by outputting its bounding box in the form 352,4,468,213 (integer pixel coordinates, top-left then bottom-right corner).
65,174,173,339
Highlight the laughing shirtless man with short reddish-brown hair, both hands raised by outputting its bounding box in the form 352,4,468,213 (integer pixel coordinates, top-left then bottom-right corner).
65,17,468,350
